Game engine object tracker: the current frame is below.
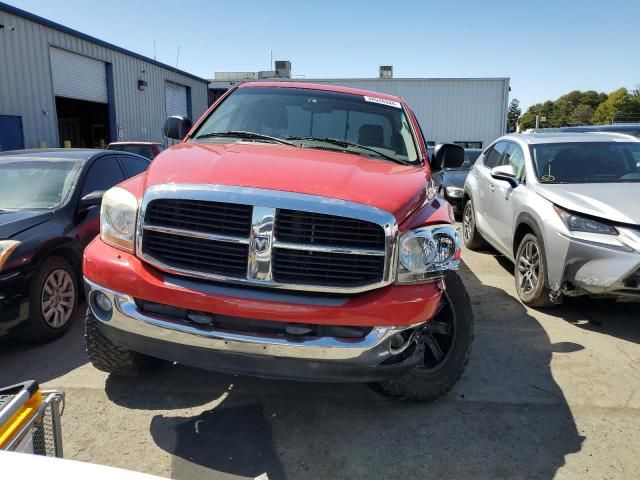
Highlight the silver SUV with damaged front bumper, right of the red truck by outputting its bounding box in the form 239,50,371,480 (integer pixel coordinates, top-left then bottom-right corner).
463,133,640,307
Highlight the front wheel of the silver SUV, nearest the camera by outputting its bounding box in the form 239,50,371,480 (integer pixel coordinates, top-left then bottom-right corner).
514,233,553,308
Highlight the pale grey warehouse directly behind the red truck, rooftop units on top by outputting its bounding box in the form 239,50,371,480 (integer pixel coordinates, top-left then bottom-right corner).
209,62,509,148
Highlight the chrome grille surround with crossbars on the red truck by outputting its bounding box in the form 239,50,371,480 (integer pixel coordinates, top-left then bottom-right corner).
136,184,398,294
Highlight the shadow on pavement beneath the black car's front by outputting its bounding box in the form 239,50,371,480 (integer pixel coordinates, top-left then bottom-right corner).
0,305,89,385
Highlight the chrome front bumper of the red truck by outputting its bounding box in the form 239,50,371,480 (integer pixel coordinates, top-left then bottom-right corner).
85,278,424,382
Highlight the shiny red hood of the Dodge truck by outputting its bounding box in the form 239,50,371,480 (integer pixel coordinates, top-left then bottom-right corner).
146,142,427,223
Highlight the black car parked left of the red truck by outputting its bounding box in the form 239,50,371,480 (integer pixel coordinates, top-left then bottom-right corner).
0,149,150,341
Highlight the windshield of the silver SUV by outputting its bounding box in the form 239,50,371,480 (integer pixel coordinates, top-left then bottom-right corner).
531,142,640,183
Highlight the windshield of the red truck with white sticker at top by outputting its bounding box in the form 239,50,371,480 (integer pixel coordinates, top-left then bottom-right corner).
191,87,419,163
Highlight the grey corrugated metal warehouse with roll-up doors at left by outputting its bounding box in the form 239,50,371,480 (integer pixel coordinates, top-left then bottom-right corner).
0,2,208,150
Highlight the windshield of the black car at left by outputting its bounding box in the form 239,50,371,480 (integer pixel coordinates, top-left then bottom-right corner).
0,158,82,210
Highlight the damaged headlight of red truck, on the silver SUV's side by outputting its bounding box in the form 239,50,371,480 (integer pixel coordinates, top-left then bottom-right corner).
398,225,460,283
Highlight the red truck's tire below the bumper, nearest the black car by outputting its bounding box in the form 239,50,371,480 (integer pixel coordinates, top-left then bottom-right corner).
84,308,159,377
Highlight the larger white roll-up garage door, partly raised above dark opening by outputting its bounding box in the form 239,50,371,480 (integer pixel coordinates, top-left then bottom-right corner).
50,48,109,103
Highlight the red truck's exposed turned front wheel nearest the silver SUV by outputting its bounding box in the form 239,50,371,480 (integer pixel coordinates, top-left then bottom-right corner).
370,272,473,401
